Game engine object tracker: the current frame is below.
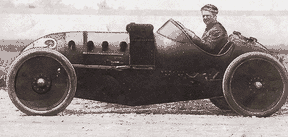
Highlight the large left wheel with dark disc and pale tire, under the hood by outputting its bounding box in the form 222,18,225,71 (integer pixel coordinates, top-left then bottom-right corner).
6,48,77,115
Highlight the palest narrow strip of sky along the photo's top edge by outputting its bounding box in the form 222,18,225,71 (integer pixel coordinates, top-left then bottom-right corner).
0,0,288,11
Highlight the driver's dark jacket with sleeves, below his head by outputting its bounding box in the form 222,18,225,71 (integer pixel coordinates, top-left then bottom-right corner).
192,22,228,54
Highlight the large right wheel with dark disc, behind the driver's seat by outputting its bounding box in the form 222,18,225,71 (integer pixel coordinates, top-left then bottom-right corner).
222,52,287,117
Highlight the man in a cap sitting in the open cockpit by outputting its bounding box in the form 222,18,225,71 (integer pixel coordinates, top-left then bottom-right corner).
188,4,228,54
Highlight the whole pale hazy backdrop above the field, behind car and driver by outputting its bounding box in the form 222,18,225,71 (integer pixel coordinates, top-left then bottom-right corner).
0,0,288,45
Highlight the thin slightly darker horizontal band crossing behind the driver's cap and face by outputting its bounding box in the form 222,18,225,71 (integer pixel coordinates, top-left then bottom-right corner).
0,8,288,16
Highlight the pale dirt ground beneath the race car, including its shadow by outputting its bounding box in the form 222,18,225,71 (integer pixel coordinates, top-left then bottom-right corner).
0,89,288,137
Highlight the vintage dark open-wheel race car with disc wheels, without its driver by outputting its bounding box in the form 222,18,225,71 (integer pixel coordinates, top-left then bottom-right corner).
6,19,287,117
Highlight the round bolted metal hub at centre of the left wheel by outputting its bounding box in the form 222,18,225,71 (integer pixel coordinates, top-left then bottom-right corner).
32,74,51,94
